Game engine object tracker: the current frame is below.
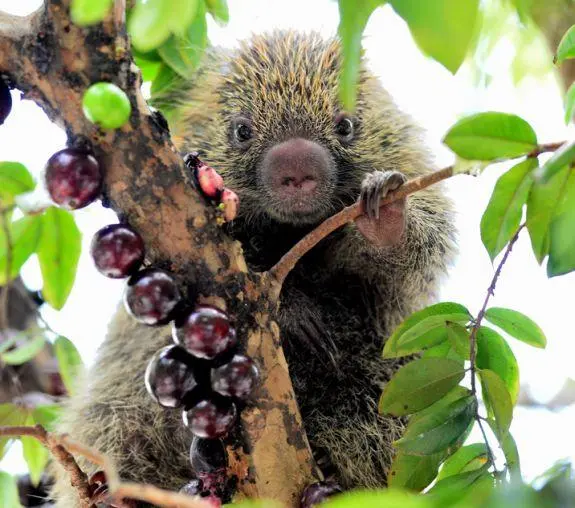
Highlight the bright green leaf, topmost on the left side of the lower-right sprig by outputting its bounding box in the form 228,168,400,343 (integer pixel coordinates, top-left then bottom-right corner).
383,302,471,358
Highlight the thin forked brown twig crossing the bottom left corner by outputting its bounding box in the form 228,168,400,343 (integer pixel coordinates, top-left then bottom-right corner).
0,425,213,508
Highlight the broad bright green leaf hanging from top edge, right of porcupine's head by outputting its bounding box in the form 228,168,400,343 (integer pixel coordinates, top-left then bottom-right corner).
389,0,479,74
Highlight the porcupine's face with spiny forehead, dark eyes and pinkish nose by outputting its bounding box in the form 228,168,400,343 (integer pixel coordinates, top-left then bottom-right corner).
216,29,360,225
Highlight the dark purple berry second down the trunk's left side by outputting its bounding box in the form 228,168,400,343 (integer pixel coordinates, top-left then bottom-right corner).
90,224,144,279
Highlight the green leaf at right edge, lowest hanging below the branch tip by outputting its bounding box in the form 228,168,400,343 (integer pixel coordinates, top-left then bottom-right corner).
547,170,575,277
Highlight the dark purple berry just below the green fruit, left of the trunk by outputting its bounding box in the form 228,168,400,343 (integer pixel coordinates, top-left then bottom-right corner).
45,148,102,210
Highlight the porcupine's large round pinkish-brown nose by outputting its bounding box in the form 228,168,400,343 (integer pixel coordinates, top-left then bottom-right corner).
262,138,329,199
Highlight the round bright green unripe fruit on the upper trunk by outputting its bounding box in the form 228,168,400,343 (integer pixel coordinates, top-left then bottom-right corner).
82,82,132,129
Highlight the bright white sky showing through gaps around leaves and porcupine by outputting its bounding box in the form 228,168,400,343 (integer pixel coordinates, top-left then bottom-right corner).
0,0,575,479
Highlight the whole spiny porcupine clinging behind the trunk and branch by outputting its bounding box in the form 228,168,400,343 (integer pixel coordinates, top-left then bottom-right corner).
56,32,460,508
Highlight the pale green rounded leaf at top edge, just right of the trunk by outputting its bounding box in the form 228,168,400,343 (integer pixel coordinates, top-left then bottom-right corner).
128,0,172,52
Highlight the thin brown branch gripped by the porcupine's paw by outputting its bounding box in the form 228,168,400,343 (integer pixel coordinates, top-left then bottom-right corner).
269,166,456,291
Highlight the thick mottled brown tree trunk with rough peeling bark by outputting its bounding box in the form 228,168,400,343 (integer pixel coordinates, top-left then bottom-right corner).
0,0,317,506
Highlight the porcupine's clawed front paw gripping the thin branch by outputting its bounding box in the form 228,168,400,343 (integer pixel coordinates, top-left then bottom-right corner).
355,171,407,248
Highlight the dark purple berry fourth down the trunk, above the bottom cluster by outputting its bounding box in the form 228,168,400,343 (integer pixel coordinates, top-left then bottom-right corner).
173,305,236,360
